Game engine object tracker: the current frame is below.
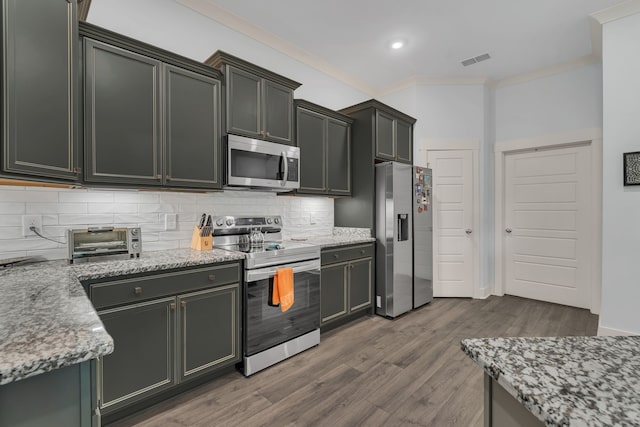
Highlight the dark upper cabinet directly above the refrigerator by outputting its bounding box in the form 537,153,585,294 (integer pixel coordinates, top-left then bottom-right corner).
341,99,416,164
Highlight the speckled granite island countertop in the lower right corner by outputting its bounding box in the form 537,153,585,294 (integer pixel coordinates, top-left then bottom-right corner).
461,336,640,426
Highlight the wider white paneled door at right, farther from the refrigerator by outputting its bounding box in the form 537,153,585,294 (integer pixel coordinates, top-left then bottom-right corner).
504,146,592,308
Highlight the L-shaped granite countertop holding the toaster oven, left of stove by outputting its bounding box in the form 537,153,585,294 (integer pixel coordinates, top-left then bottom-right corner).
0,249,244,385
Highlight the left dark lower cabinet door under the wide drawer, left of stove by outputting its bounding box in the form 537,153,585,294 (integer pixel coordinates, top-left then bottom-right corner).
97,298,176,414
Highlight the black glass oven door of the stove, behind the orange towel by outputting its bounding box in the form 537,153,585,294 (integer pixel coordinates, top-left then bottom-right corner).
243,259,320,356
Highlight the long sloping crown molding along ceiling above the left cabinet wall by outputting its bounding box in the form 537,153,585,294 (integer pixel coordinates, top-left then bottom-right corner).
176,0,376,96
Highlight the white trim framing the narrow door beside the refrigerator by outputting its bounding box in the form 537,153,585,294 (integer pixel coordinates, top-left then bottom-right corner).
414,139,480,299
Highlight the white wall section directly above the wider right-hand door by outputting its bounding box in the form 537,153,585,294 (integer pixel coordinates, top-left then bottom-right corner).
495,64,602,141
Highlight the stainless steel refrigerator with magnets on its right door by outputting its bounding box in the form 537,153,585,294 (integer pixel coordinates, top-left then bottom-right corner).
376,162,433,317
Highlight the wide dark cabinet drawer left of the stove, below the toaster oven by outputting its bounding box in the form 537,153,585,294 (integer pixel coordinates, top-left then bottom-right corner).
89,264,240,309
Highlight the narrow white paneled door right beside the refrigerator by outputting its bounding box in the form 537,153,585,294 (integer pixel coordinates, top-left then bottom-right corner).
427,150,475,297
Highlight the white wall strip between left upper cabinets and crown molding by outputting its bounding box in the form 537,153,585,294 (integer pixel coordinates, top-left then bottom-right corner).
87,0,371,109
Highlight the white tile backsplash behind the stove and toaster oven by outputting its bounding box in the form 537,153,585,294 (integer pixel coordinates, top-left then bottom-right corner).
0,185,333,259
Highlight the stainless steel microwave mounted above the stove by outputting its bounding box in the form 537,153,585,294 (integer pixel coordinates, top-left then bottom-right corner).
225,134,300,191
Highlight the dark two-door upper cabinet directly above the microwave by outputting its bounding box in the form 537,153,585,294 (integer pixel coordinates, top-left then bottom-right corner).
205,51,300,145
